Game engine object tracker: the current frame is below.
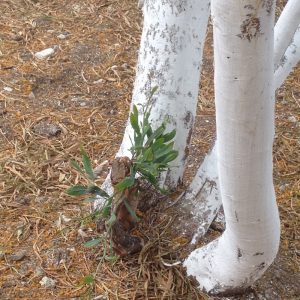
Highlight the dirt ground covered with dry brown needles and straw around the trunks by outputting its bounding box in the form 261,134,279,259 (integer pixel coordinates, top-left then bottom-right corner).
0,0,300,300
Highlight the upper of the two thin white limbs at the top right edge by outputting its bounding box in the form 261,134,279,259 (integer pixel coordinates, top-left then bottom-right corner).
274,0,300,69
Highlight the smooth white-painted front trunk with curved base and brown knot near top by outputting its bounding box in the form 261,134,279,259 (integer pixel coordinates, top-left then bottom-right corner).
185,0,280,293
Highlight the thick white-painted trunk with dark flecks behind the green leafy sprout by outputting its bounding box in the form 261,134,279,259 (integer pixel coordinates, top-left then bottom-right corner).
117,0,210,188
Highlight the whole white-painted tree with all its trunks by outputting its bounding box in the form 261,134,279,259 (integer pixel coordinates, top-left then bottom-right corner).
96,0,300,293
